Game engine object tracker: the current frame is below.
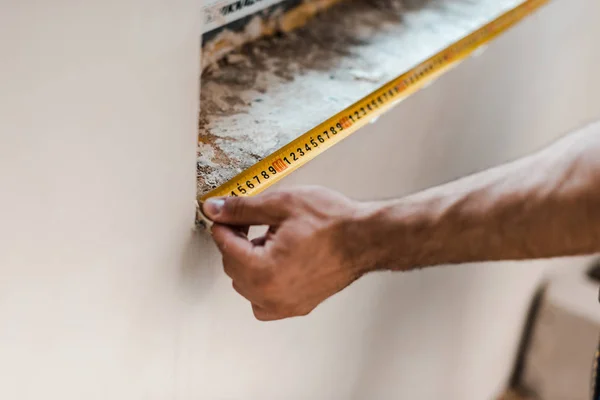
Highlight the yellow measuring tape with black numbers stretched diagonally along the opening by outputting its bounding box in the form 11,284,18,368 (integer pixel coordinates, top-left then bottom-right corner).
198,0,549,202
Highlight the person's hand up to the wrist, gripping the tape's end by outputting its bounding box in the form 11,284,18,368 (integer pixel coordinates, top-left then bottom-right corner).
203,188,367,321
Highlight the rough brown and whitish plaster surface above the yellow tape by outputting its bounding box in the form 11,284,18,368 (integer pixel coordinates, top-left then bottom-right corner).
198,0,522,195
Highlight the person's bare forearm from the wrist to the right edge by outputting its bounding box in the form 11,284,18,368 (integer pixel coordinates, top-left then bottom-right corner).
358,123,600,269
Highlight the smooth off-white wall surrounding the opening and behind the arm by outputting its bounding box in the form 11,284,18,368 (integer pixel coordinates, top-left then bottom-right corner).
0,0,600,400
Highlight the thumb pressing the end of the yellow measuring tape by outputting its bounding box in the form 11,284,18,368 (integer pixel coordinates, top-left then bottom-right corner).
202,196,287,225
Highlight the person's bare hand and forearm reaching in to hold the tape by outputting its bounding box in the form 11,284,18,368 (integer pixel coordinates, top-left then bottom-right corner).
203,122,600,321
